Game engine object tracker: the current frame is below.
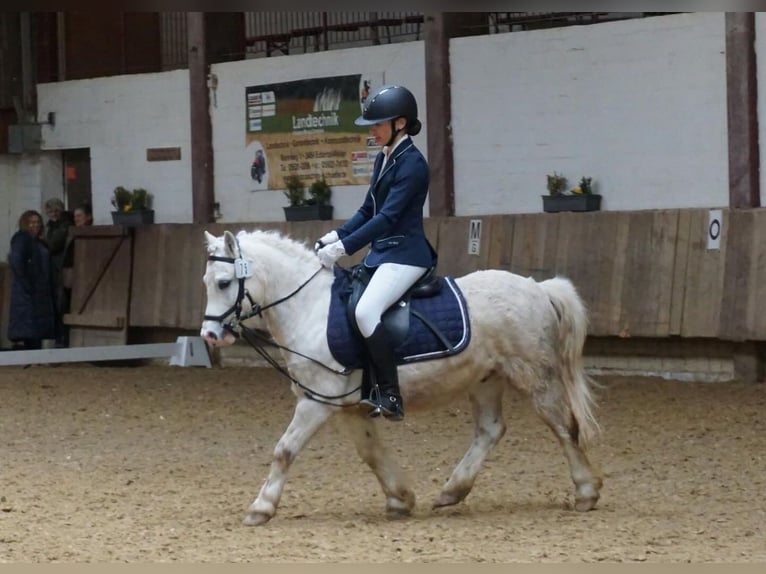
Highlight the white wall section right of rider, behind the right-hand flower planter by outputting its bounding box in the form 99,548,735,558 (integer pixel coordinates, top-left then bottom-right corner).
450,12,732,215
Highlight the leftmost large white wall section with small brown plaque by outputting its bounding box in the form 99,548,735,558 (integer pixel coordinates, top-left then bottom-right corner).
37,70,192,224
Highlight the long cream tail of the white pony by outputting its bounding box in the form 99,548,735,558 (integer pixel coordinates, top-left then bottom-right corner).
540,277,600,445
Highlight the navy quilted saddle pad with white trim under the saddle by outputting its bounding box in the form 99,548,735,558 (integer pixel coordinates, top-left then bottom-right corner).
327,265,471,369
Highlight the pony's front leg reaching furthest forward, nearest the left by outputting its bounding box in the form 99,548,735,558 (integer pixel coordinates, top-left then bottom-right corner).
244,398,333,526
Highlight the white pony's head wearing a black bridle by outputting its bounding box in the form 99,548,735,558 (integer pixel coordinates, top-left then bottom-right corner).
200,231,262,347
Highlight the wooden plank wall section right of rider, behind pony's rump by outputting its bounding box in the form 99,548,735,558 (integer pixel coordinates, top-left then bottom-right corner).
432,209,744,341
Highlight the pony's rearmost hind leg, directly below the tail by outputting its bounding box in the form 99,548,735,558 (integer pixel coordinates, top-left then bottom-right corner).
532,379,602,512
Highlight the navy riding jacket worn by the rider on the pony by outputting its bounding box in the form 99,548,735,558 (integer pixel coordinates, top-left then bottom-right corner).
336,138,436,267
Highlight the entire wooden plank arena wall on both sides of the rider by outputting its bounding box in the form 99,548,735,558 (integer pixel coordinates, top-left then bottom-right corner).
24,209,766,341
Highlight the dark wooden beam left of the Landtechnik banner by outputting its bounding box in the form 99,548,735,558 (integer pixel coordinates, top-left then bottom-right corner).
186,12,215,223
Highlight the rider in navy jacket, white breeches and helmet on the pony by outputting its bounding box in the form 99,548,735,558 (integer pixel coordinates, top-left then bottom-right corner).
314,85,436,420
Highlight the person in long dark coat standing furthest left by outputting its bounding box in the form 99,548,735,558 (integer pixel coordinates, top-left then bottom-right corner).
8,210,56,350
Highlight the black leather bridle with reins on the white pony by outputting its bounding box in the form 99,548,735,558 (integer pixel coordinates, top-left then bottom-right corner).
204,241,361,407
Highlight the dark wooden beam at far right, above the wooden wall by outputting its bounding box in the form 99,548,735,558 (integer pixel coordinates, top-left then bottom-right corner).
726,12,761,208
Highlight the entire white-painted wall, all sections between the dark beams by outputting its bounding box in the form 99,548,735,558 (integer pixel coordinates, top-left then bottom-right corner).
0,12,744,243
